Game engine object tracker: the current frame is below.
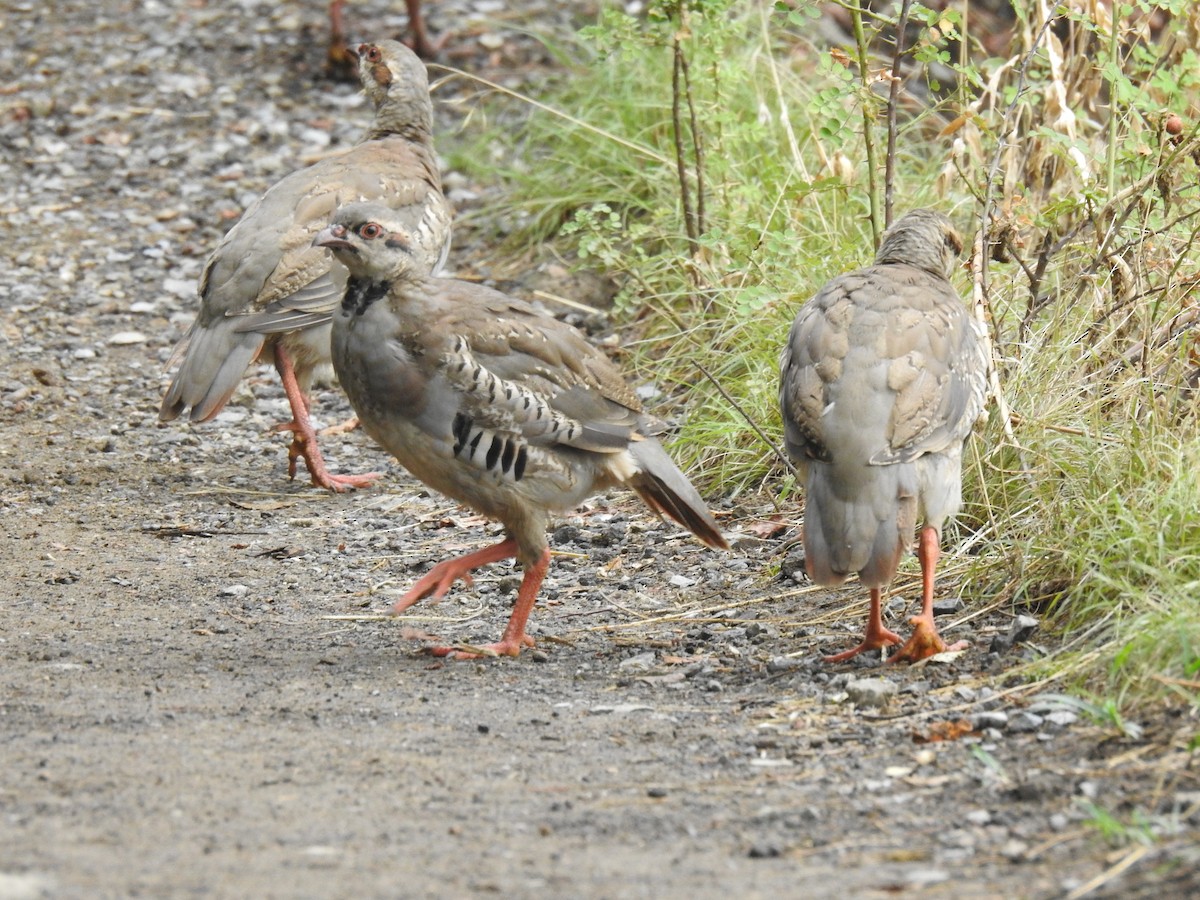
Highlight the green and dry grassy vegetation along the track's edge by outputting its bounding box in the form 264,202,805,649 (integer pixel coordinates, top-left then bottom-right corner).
455,0,1200,719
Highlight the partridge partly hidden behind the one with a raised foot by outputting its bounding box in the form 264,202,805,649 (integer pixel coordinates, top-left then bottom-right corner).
160,41,451,491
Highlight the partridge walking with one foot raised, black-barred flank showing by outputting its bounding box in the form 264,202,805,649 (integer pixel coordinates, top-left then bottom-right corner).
314,204,728,659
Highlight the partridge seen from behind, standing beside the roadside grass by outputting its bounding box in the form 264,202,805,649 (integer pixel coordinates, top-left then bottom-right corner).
779,210,988,662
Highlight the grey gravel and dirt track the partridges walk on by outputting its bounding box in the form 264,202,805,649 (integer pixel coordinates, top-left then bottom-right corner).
0,0,1200,900
